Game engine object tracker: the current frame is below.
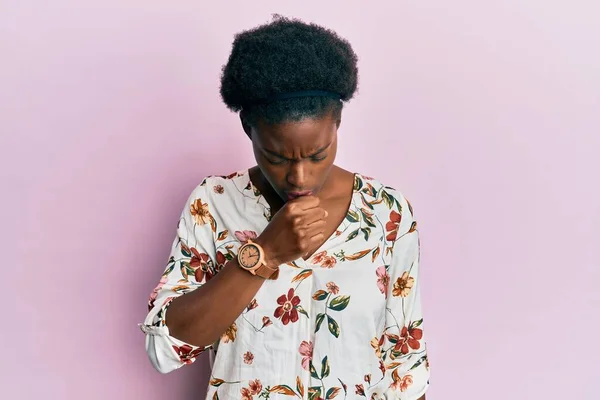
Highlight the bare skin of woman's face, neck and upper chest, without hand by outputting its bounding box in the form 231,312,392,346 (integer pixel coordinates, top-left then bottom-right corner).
242,106,354,259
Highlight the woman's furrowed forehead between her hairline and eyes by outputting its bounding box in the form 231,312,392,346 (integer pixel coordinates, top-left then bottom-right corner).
253,116,337,156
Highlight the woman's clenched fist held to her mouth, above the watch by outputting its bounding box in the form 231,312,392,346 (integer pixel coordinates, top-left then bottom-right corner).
255,196,328,268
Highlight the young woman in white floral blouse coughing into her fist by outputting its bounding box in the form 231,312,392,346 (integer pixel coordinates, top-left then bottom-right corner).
141,18,429,400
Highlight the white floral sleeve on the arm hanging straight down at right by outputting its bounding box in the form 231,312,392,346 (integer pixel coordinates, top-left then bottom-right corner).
379,195,429,400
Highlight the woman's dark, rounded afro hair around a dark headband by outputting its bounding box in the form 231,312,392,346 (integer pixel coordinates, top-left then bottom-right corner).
221,16,358,123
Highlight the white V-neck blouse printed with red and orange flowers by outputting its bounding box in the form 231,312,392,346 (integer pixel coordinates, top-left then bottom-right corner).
140,170,429,400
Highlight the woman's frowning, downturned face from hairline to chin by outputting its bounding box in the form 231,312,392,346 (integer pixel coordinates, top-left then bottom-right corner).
244,113,340,201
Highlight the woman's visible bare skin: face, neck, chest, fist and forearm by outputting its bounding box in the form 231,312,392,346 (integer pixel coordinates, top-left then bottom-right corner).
167,108,425,400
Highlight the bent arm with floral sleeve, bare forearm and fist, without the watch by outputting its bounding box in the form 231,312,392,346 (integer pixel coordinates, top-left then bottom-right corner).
141,185,324,373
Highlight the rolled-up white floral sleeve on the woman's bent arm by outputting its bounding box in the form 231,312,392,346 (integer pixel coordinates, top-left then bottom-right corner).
139,184,217,374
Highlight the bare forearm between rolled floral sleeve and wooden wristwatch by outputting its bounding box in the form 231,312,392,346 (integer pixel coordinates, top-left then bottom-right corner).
166,259,264,347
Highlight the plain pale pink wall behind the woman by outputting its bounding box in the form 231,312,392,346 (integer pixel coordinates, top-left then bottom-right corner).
0,0,600,400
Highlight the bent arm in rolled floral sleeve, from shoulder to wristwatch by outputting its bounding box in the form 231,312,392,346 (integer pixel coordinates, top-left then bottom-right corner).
141,185,270,373
